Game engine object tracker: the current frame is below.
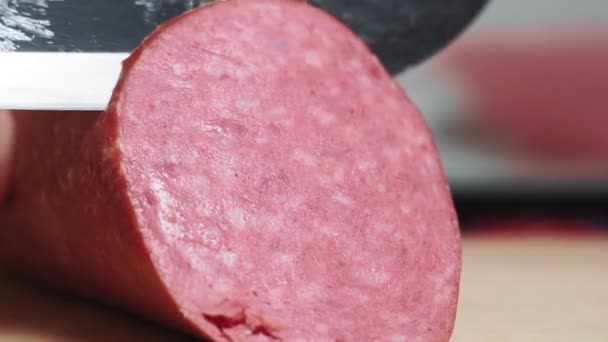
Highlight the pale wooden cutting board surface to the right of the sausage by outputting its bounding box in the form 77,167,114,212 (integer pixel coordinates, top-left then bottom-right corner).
452,238,608,342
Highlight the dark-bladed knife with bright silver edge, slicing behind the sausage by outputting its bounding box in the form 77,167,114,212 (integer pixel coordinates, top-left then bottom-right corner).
0,0,487,110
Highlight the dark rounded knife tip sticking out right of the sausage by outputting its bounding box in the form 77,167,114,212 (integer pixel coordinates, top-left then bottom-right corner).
310,0,488,74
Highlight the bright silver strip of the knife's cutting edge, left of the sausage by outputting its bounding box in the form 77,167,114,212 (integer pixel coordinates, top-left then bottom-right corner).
0,52,128,110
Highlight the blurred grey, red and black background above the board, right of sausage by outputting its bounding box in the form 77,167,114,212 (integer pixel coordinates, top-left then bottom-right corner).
399,0,608,227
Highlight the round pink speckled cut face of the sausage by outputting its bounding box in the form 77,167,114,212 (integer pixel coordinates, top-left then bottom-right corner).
110,1,459,341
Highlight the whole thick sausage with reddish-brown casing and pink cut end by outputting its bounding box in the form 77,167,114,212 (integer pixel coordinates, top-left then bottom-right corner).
0,0,460,341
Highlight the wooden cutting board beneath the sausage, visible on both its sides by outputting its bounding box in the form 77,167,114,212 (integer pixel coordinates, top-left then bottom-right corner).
0,238,608,342
